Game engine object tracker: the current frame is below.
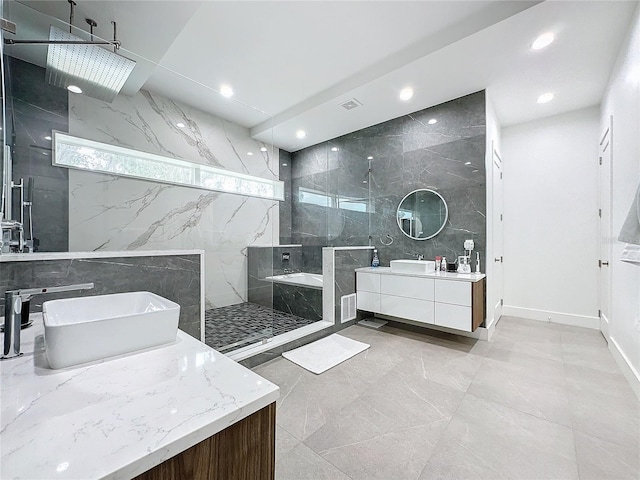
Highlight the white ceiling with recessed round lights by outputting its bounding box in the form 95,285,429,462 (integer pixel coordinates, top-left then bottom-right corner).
10,0,638,151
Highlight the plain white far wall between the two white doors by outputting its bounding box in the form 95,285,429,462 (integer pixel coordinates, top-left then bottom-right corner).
502,107,599,328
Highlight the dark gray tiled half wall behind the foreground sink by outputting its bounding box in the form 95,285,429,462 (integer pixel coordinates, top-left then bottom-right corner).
0,255,201,340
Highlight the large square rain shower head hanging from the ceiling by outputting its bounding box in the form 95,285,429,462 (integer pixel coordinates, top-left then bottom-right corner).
47,26,136,102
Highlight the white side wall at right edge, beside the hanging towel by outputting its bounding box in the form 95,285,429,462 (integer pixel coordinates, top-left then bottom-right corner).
601,2,640,396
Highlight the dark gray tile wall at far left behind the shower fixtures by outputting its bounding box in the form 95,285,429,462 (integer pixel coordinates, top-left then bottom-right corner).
5,56,69,252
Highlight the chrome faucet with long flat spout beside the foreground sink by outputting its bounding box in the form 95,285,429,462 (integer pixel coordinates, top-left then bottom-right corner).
0,283,94,360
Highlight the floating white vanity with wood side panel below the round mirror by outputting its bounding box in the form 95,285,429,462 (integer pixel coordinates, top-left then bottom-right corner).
356,267,485,332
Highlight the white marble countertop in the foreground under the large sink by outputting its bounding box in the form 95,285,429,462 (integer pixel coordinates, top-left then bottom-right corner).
0,314,279,479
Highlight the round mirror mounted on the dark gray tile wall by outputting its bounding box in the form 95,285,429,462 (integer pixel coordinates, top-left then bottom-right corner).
397,188,449,240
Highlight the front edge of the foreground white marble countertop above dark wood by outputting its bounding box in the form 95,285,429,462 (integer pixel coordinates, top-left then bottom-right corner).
110,389,280,480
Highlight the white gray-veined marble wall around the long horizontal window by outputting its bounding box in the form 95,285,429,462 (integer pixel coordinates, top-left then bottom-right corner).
69,91,279,308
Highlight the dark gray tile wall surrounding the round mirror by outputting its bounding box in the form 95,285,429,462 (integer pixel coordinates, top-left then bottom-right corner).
284,91,486,268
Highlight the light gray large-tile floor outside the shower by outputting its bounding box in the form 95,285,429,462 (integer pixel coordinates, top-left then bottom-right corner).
254,317,640,480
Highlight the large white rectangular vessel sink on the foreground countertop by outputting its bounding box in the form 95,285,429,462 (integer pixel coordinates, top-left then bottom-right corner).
42,292,180,369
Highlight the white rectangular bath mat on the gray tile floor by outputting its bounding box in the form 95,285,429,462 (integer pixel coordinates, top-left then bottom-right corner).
282,333,370,374
